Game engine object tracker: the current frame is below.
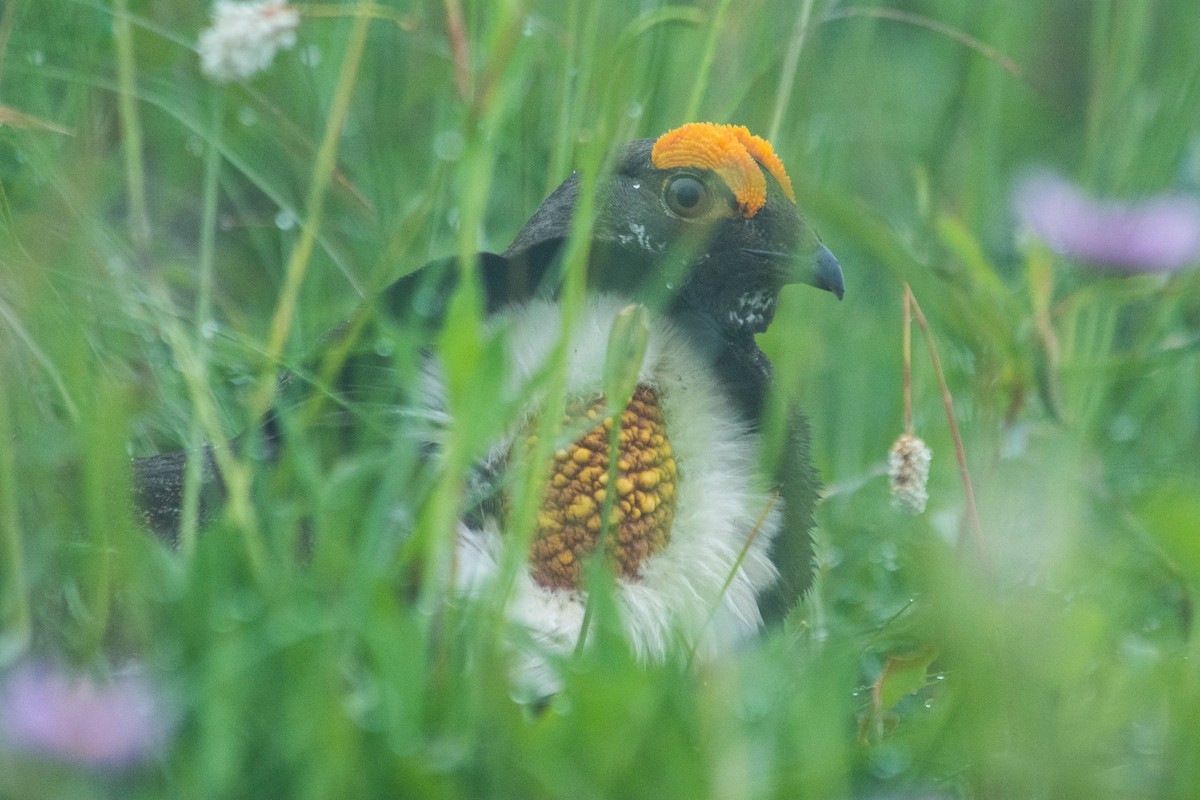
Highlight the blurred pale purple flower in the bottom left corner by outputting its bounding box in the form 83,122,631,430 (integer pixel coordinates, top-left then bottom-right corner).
0,664,168,766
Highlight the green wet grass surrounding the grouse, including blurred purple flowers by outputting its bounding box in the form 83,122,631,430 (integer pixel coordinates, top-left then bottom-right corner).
0,0,1200,799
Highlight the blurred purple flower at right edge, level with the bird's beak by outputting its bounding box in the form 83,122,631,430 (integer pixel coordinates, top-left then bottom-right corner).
1014,172,1200,272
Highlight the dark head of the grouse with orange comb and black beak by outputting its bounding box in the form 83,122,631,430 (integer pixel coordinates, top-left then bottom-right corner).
505,122,844,333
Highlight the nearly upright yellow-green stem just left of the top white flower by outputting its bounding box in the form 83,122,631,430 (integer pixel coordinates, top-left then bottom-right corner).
113,0,150,259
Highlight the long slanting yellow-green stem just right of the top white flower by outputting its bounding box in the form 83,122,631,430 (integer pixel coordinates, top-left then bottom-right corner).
251,0,372,416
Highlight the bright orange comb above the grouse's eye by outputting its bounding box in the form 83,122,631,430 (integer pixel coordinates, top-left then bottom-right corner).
650,122,796,217
